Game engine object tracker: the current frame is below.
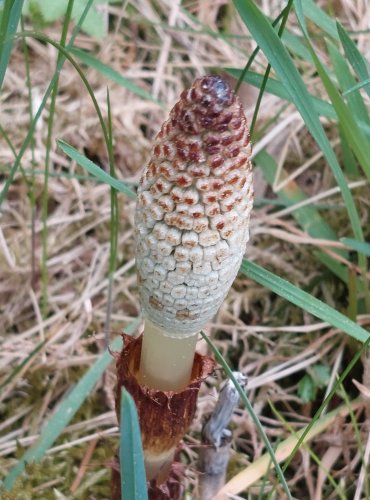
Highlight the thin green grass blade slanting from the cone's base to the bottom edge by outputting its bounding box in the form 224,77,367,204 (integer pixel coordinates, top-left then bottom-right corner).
201,332,292,499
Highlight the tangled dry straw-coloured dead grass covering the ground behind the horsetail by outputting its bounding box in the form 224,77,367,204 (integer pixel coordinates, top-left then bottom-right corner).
0,0,370,499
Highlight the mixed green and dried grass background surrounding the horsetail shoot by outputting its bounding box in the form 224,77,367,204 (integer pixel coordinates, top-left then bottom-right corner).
0,0,370,499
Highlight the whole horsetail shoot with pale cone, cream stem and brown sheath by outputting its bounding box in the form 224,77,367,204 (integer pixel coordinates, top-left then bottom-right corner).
117,75,253,490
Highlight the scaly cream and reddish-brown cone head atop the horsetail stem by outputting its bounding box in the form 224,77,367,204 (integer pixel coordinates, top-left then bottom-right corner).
136,76,253,335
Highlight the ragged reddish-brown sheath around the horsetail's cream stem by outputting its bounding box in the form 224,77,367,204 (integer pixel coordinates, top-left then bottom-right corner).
116,335,215,494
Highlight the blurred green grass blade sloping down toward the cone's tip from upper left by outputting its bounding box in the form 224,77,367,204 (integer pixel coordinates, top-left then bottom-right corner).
70,47,164,107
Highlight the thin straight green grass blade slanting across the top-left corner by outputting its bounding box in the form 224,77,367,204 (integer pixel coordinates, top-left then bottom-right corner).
0,0,94,207
